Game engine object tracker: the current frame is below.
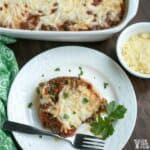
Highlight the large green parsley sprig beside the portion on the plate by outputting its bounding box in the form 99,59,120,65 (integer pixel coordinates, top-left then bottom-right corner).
91,101,127,139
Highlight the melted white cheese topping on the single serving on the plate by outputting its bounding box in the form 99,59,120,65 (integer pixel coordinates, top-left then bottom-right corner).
40,78,106,132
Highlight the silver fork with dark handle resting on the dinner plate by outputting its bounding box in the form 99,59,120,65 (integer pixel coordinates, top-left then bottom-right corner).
3,121,104,150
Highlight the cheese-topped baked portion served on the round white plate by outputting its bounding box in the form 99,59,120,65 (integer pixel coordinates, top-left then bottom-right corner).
38,77,107,137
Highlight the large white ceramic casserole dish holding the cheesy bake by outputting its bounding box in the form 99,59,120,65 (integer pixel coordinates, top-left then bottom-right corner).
0,0,139,42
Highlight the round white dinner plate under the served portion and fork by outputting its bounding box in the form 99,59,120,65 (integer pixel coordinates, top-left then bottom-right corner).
8,46,137,150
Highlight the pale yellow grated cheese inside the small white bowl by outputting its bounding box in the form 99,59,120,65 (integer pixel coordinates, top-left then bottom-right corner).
122,33,150,74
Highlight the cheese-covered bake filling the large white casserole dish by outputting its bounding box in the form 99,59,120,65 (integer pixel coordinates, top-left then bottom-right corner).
0,0,125,31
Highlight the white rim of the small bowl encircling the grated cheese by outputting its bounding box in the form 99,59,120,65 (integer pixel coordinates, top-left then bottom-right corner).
117,22,150,79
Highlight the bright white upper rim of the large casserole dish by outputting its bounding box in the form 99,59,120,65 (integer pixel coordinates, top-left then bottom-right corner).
0,0,139,35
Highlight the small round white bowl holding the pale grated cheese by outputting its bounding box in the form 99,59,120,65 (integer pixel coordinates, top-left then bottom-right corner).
117,22,150,79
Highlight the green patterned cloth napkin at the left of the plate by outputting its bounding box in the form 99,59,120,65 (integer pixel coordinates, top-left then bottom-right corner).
0,35,18,150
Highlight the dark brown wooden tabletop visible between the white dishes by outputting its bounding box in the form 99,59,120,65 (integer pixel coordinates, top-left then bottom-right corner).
11,0,150,150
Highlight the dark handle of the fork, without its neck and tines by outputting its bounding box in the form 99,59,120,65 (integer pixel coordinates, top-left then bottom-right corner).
3,121,64,139
